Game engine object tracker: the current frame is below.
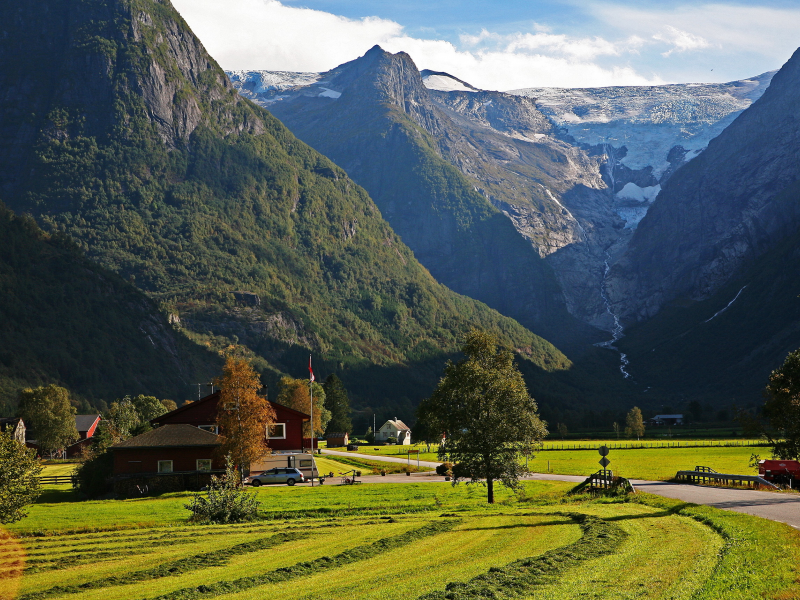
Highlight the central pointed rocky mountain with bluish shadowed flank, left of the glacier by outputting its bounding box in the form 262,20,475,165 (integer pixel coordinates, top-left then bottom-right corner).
231,46,622,345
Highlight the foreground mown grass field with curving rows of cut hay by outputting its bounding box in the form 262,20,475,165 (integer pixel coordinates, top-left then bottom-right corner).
0,482,800,600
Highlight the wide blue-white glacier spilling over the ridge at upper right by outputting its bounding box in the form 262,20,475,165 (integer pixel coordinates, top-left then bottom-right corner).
508,71,775,180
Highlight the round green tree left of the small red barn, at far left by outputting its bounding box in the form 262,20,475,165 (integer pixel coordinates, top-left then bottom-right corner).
17,384,78,455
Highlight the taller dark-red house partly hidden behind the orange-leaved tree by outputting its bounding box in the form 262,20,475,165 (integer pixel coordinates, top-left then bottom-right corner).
150,392,311,452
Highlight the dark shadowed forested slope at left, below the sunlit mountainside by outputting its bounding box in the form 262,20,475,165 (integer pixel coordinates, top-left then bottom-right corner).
0,205,221,415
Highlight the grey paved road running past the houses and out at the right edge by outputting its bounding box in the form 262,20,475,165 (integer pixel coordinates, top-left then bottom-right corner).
322,450,800,529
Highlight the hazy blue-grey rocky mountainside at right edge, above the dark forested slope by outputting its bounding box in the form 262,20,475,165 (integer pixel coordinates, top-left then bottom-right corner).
608,48,800,321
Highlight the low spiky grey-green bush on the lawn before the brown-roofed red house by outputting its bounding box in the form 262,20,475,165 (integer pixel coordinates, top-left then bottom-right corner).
184,459,259,523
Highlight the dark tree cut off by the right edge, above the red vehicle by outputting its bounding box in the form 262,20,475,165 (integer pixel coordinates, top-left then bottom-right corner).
764,350,800,460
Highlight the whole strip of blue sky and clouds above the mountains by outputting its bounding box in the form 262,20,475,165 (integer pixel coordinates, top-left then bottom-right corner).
172,0,800,91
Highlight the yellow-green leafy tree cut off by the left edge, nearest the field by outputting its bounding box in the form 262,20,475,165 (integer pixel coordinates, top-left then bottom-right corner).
0,431,42,523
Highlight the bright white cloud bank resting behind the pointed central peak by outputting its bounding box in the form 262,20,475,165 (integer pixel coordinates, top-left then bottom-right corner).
173,0,661,90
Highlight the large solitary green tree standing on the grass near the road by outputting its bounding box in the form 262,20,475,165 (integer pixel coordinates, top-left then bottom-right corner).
418,329,547,503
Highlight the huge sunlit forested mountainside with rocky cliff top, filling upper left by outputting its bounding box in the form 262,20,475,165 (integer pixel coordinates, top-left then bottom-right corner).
0,0,569,412
